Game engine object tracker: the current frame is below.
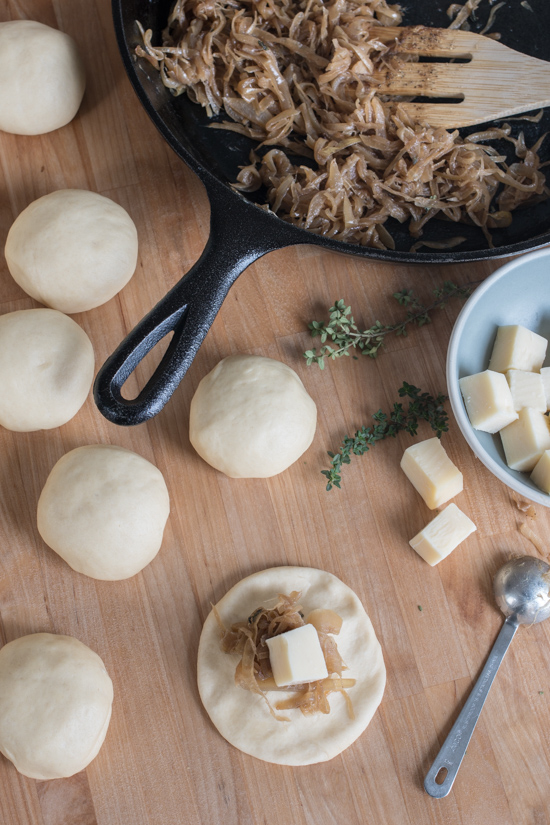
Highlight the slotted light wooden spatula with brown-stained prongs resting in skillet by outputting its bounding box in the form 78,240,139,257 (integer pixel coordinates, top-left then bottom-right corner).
372,26,550,128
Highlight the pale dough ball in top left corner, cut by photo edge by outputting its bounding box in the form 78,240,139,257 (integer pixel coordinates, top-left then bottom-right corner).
0,20,86,135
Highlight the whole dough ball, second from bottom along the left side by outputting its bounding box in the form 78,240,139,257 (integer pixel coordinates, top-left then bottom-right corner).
38,444,170,581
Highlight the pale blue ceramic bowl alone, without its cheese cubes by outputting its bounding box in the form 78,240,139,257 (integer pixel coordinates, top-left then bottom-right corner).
447,247,550,507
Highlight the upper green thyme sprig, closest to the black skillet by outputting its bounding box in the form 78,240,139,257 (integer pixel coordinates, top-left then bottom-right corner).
304,281,481,369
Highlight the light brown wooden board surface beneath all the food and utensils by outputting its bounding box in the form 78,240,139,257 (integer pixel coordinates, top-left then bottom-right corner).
0,0,550,825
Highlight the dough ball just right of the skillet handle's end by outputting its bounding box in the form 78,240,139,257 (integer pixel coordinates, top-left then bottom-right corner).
189,355,317,478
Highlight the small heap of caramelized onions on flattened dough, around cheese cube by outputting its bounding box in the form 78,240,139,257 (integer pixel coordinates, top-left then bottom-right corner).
213,590,355,722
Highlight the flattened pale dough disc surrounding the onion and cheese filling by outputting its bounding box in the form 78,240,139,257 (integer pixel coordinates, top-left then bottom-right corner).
198,567,386,765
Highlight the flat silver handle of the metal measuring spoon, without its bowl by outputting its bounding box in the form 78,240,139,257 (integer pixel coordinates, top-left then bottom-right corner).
424,616,519,799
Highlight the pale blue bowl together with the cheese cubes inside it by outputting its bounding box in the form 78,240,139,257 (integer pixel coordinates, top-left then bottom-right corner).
447,248,550,507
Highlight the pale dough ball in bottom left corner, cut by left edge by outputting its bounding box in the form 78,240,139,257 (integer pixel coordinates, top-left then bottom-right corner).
0,633,113,779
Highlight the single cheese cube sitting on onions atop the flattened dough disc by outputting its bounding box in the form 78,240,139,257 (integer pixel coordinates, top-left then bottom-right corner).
266,624,328,687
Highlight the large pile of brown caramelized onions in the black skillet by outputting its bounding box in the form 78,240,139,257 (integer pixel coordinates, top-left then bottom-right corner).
136,0,548,249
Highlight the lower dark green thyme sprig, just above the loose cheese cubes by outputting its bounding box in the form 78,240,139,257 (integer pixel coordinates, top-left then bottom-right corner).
321,381,449,490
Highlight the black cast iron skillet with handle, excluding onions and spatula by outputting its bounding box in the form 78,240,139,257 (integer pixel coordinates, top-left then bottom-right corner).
94,0,550,425
